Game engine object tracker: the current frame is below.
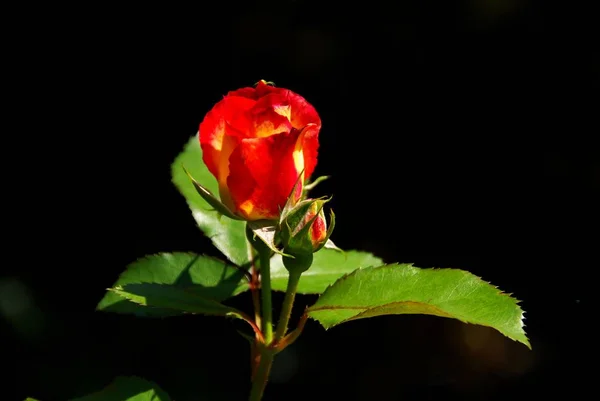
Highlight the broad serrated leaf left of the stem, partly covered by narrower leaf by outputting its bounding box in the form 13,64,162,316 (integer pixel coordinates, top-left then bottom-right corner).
97,252,248,317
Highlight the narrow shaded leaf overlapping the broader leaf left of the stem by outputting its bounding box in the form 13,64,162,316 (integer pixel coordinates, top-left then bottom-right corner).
109,283,240,316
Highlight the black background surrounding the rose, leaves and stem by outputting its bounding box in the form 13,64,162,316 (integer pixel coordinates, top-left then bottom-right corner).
0,0,600,401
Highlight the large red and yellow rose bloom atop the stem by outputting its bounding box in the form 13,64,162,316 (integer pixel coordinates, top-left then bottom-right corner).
200,81,321,220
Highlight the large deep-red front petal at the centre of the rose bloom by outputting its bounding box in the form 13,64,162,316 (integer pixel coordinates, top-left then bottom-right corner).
227,129,306,220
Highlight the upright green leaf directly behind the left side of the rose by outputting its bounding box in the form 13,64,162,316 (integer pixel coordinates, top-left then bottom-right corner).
171,135,250,266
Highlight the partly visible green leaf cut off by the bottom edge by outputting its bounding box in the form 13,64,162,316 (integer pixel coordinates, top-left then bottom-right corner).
71,376,171,401
